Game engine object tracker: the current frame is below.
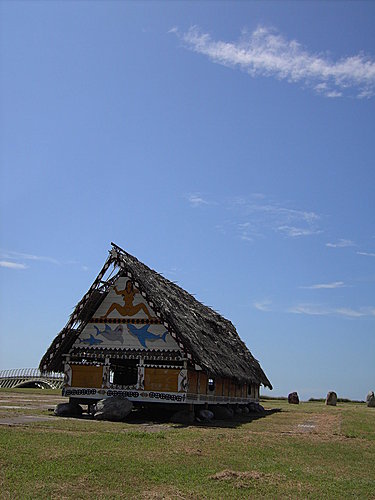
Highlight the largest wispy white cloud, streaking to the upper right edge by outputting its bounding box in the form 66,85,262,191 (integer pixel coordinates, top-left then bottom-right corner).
176,26,375,98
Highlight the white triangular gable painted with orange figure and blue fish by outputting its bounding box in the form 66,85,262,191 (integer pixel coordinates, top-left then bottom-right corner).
73,277,180,351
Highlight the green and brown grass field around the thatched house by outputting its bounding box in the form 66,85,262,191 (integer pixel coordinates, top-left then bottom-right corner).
0,390,375,499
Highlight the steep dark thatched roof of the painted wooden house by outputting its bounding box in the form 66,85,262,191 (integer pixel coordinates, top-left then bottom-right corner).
40,243,272,389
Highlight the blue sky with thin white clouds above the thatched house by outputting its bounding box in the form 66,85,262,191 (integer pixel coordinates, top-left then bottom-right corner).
0,1,375,399
